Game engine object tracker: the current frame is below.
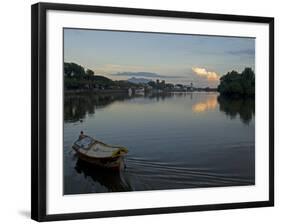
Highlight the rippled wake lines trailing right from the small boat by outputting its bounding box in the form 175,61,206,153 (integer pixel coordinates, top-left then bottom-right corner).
123,158,255,190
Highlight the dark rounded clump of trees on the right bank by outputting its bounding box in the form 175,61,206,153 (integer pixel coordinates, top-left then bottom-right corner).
218,68,255,96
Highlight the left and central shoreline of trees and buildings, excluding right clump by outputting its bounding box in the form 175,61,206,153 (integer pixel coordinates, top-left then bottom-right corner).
64,62,217,94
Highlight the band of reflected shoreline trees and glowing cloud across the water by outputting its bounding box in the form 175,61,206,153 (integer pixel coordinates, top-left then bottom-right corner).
64,92,255,124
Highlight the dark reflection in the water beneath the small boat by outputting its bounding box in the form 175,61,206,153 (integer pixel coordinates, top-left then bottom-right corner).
75,159,132,192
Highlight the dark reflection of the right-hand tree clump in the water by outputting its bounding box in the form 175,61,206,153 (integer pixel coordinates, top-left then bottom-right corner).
218,96,255,124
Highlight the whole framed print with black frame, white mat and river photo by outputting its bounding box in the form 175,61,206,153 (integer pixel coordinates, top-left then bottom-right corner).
31,3,274,221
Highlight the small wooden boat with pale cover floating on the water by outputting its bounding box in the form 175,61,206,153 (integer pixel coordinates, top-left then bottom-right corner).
72,136,128,170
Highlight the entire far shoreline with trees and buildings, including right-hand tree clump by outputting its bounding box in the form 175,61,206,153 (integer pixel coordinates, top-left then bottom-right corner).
64,62,255,97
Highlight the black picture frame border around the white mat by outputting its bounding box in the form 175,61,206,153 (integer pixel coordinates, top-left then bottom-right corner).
31,3,274,221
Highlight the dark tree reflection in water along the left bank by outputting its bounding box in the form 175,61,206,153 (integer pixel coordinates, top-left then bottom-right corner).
64,93,129,122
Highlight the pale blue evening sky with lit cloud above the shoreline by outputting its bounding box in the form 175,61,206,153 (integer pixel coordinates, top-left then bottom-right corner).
64,28,255,87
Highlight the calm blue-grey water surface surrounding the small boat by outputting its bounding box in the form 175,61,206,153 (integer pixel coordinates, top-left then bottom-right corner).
63,92,255,194
